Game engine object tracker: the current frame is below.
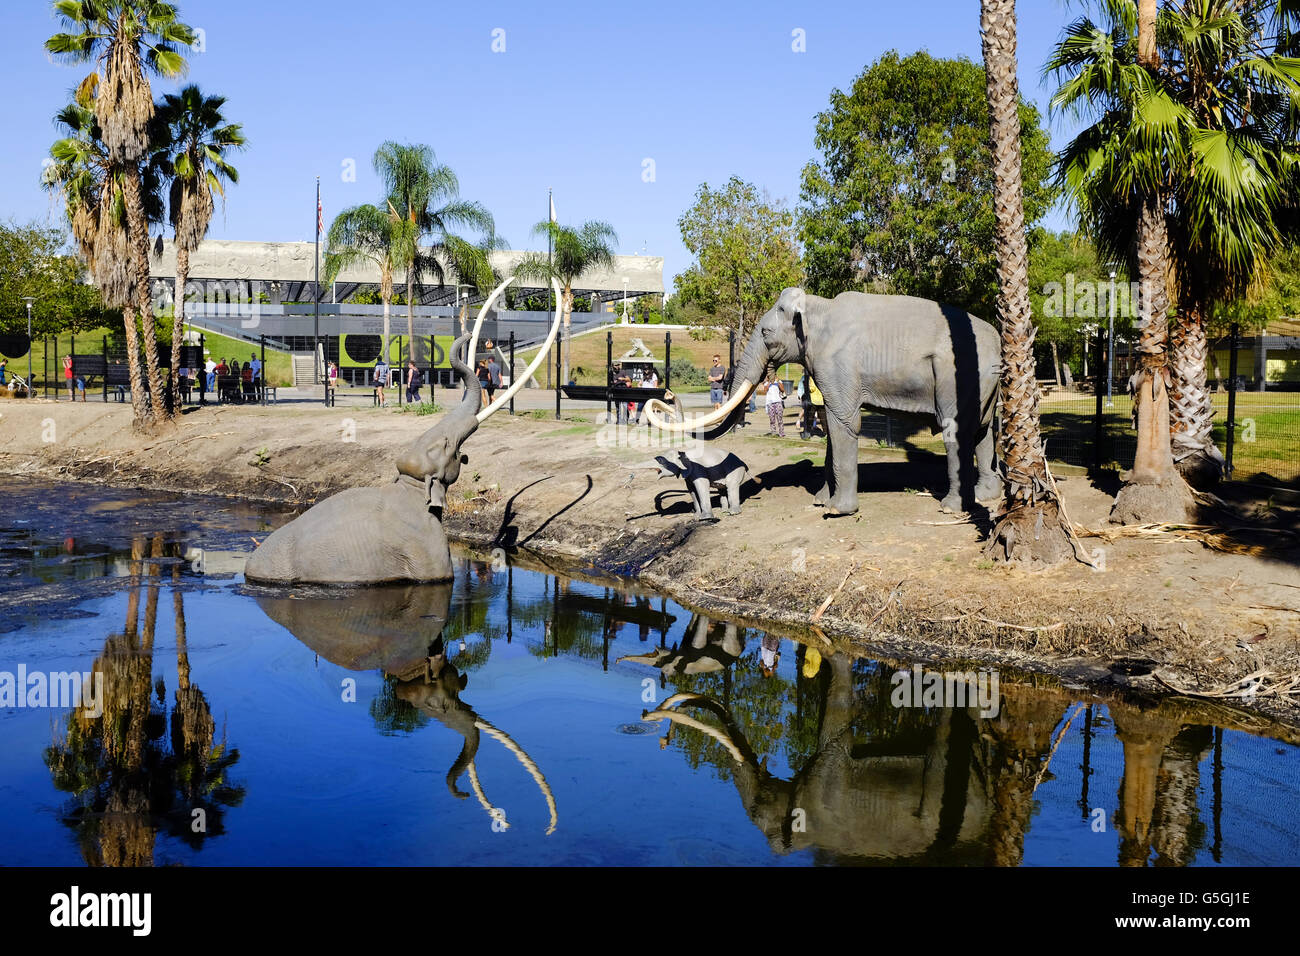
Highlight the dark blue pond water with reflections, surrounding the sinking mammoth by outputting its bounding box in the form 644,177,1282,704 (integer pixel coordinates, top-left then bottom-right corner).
0,483,1300,866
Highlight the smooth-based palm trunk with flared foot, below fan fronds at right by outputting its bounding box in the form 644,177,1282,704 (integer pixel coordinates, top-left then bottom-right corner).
1110,195,1193,524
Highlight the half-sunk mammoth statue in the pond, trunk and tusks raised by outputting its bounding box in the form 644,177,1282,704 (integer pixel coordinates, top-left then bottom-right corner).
244,278,559,585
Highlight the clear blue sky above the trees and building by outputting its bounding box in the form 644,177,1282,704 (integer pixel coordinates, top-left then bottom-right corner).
0,0,1073,286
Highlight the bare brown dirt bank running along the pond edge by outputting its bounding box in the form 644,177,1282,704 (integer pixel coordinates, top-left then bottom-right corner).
0,393,1300,722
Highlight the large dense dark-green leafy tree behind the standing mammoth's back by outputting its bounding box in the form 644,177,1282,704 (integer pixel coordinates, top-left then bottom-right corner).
800,52,1054,317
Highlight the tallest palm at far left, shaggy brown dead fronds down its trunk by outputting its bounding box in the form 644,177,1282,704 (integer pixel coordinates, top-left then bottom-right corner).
46,0,195,425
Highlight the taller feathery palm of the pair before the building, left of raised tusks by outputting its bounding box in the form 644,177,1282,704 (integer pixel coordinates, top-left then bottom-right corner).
373,140,495,353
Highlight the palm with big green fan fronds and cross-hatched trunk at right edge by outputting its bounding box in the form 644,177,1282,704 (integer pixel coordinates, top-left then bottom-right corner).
1048,0,1297,489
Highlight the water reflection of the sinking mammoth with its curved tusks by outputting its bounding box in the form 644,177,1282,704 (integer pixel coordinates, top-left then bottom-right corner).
250,583,558,835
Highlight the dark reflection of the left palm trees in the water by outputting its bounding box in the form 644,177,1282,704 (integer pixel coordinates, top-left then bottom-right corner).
44,536,244,866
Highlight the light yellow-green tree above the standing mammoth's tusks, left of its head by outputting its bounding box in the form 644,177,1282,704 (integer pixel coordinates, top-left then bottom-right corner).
675,176,802,338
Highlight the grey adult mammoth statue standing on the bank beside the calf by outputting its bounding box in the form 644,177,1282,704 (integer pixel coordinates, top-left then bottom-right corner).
646,289,1002,515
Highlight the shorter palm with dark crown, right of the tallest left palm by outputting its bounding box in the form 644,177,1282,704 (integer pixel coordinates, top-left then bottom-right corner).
155,83,247,407
